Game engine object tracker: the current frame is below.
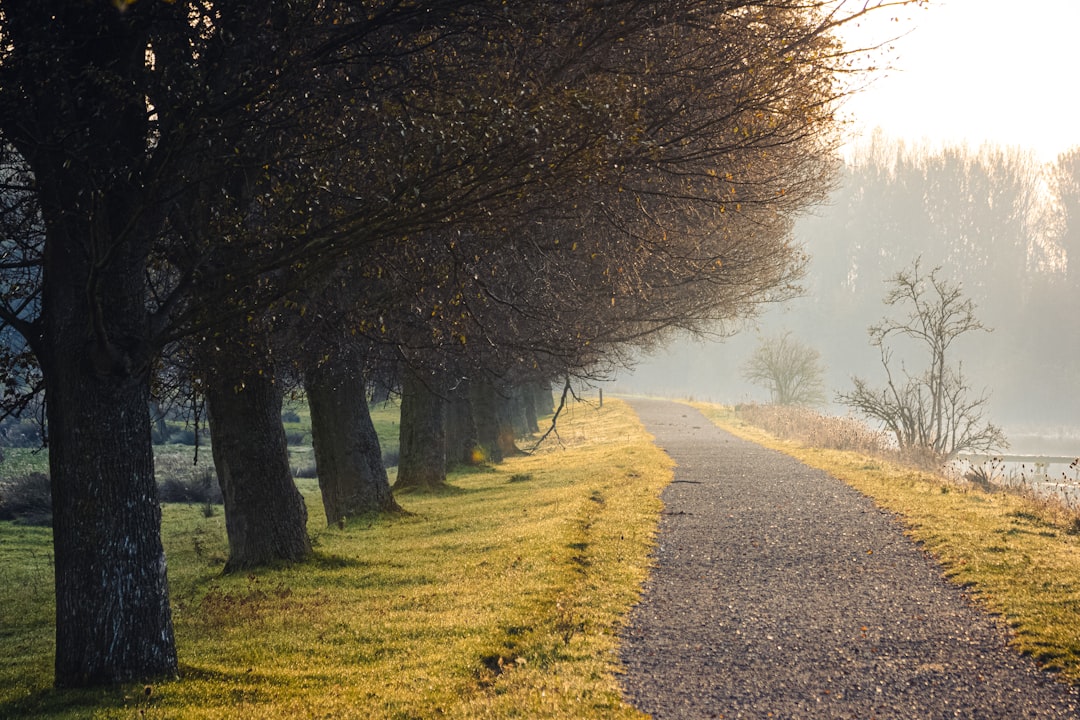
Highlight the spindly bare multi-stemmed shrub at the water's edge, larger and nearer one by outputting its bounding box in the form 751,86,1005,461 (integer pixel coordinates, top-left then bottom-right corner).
837,259,1009,458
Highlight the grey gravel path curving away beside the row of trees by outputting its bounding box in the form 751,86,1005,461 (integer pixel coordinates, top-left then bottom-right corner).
622,400,1080,720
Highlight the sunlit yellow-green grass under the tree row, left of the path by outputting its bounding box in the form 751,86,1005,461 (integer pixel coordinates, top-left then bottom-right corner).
0,400,671,719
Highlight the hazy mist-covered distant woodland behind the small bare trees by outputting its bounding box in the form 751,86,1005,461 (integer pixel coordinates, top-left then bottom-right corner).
610,133,1080,453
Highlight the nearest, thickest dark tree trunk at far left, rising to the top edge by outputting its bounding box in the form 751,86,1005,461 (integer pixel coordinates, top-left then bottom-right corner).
13,3,177,687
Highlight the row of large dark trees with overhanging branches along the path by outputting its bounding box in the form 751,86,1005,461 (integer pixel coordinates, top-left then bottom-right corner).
0,0,911,685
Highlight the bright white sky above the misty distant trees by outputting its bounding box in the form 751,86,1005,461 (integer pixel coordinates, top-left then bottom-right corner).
845,0,1080,161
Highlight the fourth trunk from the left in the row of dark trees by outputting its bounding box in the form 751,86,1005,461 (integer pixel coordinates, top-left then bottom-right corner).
394,368,446,490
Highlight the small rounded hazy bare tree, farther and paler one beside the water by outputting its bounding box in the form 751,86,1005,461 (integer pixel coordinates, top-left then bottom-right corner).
742,332,825,407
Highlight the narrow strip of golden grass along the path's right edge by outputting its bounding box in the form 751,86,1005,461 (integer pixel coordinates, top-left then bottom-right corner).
693,403,1080,682
